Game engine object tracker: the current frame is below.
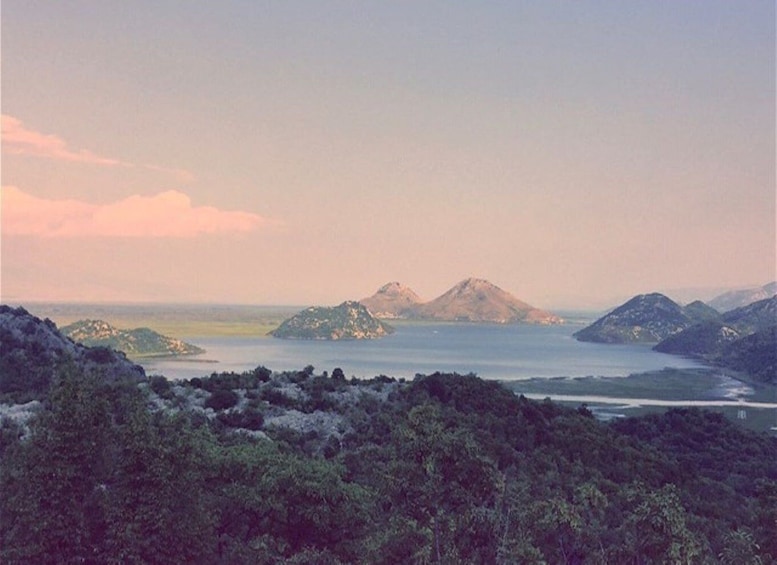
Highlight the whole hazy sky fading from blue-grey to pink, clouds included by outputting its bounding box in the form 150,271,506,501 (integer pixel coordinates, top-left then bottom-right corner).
0,0,777,308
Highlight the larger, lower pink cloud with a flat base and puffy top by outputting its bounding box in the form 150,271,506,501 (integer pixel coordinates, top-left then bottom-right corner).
2,186,271,237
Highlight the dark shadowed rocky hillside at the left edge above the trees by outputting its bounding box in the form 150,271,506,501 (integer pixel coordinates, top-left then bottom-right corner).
0,306,146,402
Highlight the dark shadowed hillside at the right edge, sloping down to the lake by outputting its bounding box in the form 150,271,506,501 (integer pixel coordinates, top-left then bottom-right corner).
654,296,777,382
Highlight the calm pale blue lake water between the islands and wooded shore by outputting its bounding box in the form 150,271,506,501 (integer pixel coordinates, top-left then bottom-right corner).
142,323,701,380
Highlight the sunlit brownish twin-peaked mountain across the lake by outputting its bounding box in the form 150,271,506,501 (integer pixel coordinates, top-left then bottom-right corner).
359,278,563,325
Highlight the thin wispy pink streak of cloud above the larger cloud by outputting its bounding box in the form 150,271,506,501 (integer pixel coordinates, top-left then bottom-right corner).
1,114,194,182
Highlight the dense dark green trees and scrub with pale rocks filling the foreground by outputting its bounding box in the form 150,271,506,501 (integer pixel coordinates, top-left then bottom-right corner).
0,364,777,564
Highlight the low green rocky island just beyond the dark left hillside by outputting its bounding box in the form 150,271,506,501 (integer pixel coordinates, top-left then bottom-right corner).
61,320,205,357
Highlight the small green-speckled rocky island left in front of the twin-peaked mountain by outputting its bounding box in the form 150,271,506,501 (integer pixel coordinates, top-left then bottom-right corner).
270,301,394,340
